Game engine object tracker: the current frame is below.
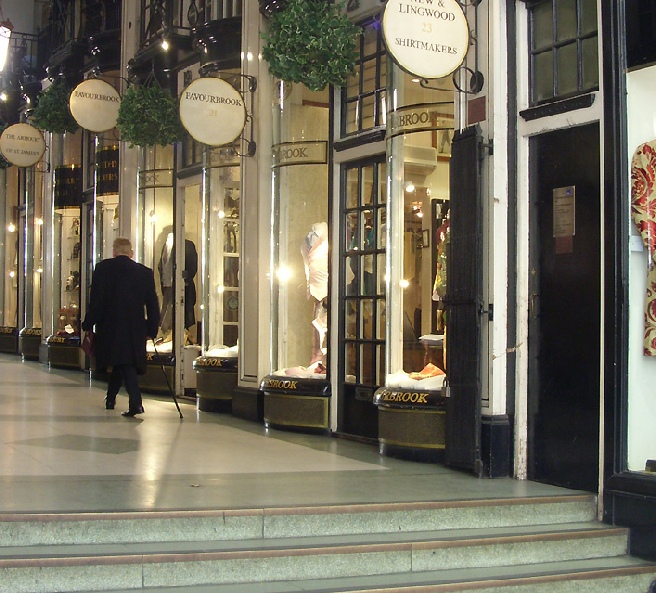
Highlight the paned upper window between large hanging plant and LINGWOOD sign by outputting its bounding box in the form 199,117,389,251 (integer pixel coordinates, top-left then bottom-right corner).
341,22,387,137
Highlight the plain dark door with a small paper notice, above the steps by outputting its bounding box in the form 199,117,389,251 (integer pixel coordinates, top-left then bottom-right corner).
528,124,601,492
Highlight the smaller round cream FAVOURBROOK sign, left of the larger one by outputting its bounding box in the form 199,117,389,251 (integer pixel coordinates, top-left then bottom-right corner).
69,78,121,132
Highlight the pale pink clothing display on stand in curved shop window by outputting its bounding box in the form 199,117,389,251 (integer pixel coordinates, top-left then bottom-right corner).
301,222,328,365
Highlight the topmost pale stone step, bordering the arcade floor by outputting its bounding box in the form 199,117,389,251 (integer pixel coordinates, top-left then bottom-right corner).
0,495,596,548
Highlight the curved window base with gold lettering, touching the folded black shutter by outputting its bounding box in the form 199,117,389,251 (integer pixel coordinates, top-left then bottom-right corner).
373,387,447,462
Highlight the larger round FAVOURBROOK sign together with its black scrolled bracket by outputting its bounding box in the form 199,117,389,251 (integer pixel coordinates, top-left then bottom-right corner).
180,73,257,156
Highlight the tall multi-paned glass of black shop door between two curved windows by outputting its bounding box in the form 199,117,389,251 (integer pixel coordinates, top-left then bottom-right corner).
340,161,387,386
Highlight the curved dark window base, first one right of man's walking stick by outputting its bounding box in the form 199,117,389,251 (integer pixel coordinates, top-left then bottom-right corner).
194,356,237,413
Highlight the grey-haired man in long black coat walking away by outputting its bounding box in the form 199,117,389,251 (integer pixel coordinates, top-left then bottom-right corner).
82,237,159,416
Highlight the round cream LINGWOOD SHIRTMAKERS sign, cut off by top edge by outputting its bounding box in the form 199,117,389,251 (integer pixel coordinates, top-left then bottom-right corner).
383,0,469,78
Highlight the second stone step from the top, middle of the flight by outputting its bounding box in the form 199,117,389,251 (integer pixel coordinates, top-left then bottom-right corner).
0,525,627,593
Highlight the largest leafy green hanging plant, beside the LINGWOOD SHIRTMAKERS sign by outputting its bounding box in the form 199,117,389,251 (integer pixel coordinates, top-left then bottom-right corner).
262,0,362,91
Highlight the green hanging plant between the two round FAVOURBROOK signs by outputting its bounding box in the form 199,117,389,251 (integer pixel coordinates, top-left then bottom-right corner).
116,83,185,148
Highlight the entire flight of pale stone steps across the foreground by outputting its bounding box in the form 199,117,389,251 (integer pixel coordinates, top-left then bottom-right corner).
0,494,656,593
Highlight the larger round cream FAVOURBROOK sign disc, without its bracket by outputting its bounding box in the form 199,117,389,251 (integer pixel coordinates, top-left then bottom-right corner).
180,78,246,146
